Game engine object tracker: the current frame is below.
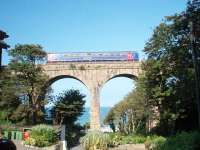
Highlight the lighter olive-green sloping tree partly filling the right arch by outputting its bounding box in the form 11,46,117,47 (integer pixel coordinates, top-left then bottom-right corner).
104,77,152,134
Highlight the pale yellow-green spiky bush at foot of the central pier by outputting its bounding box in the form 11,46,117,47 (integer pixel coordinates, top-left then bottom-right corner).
80,131,110,150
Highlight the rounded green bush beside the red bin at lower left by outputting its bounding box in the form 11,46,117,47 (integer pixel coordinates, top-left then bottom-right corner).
25,125,57,147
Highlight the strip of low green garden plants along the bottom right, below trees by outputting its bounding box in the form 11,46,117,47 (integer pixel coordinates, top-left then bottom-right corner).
80,131,200,150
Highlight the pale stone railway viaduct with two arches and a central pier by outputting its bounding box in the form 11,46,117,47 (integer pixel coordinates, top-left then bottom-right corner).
43,61,141,129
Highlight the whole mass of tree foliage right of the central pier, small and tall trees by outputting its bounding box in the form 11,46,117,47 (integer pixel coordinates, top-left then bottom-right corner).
105,0,200,135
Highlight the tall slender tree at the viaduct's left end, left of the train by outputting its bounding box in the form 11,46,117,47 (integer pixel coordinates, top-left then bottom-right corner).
9,44,48,124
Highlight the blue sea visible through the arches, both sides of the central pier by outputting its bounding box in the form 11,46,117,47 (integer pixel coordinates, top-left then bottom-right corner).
78,107,111,125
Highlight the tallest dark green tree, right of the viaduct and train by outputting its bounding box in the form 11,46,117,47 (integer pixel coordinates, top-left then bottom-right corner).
142,0,200,134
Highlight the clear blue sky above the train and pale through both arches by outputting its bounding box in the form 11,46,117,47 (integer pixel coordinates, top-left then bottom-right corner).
0,0,187,106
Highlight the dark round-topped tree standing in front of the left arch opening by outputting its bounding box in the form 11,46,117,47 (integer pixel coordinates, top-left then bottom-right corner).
53,90,85,147
